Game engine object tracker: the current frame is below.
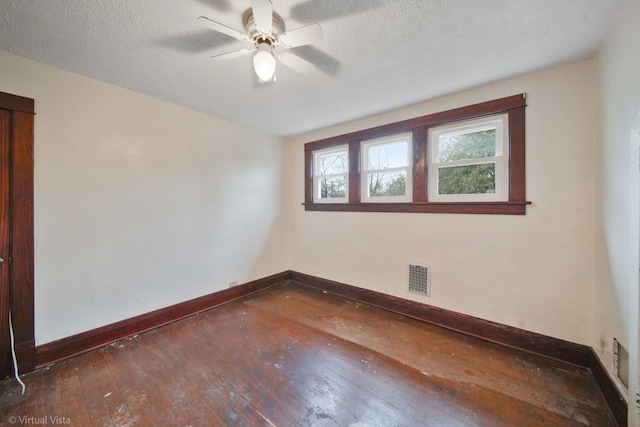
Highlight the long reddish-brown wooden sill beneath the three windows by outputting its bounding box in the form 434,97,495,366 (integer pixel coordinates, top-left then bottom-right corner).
303,201,531,215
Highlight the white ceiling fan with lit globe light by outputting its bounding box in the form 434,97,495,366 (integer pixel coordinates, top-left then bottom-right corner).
198,0,323,82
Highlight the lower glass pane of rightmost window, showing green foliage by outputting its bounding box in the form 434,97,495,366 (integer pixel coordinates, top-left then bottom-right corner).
438,163,496,194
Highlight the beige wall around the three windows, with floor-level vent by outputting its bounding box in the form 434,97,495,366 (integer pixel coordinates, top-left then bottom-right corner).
289,61,595,345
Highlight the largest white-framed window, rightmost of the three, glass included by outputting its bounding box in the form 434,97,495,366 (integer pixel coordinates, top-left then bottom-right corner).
427,114,509,202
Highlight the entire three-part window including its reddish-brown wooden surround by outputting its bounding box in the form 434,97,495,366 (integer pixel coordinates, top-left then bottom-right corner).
304,94,530,215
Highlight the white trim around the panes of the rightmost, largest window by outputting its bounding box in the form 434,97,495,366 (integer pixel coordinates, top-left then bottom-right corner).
427,114,509,202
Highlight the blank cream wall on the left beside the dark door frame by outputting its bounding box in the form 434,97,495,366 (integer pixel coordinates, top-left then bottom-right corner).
0,52,289,345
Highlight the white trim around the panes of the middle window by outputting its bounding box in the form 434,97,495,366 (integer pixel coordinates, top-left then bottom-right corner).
360,132,413,203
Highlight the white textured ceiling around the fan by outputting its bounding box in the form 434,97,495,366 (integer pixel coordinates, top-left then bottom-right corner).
0,0,627,136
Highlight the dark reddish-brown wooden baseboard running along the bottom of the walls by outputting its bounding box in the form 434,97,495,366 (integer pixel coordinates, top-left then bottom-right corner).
35,271,627,426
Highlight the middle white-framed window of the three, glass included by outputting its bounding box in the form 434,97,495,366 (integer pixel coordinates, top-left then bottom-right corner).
360,132,412,203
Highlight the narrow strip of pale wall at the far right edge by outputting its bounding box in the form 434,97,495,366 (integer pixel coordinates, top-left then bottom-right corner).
592,1,640,418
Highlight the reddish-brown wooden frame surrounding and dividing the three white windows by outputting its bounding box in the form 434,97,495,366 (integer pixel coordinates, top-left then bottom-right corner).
303,93,531,215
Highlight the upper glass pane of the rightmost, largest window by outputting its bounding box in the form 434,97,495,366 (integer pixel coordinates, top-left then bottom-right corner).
438,128,496,162
